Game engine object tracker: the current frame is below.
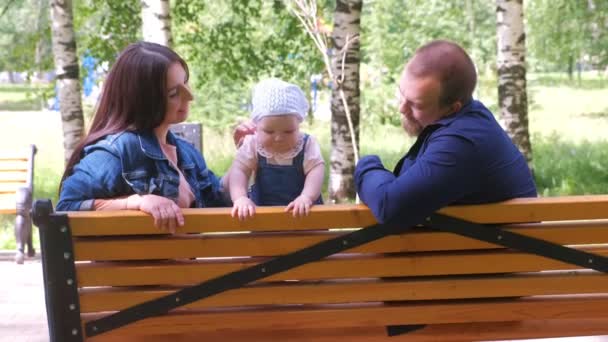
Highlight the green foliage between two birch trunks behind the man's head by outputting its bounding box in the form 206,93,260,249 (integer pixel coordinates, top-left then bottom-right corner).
361,0,496,125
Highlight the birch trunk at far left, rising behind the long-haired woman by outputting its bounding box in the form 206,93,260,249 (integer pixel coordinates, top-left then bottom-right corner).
51,0,84,166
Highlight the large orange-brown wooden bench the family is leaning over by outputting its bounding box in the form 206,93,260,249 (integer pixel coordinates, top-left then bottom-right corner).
34,195,608,342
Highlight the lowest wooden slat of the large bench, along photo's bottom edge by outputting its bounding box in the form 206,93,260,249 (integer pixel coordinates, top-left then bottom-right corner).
86,319,608,342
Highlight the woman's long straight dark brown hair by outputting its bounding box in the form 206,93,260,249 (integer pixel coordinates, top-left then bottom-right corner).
60,42,189,189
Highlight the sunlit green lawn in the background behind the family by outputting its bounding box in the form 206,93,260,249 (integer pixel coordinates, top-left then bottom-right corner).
0,73,608,248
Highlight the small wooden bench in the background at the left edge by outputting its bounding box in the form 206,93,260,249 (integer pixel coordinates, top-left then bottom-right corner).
0,145,36,264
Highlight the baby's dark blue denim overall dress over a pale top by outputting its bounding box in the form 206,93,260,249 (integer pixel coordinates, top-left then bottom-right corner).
250,134,323,205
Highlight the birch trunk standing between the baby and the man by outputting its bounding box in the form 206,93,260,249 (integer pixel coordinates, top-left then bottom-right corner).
329,0,363,203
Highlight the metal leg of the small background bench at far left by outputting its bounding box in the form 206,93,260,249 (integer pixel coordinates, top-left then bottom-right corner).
15,188,35,264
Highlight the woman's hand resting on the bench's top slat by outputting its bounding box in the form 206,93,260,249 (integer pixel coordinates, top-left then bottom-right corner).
137,195,184,234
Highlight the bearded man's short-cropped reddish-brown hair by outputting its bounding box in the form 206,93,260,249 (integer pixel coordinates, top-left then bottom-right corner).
408,40,477,106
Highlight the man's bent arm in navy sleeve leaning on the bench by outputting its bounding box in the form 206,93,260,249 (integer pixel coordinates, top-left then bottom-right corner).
355,135,482,225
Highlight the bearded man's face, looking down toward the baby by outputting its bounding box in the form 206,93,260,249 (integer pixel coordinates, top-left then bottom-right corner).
398,63,451,136
